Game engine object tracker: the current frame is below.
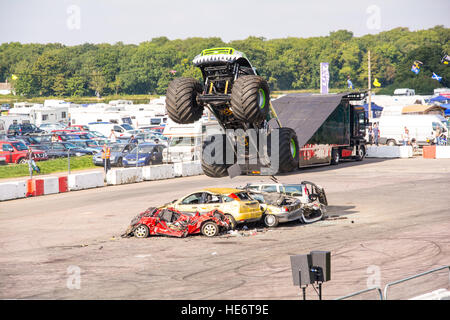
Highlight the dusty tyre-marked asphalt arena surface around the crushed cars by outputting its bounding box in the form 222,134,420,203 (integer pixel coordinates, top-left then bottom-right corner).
0,158,450,299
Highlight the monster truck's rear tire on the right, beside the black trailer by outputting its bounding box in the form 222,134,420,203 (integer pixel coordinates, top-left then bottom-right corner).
267,128,300,173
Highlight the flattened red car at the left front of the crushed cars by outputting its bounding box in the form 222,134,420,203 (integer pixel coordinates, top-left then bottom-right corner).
122,207,230,238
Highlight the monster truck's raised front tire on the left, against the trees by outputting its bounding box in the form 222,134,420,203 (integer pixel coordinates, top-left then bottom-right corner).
166,78,203,124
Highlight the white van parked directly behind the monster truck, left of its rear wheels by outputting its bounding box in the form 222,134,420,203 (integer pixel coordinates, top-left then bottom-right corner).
163,119,222,162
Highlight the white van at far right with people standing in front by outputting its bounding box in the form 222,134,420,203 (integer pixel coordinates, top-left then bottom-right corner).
378,114,448,146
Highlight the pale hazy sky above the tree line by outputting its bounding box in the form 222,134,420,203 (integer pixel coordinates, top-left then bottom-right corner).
0,0,450,45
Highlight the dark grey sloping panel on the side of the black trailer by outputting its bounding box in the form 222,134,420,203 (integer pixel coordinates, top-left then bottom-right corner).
272,93,348,148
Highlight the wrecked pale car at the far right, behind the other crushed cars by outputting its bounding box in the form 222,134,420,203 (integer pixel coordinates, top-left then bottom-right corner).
243,181,328,223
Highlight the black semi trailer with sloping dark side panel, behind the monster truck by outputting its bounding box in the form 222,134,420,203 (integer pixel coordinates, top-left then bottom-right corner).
273,92,367,167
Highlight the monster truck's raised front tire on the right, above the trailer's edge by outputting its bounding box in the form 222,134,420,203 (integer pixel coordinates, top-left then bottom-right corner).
231,75,270,123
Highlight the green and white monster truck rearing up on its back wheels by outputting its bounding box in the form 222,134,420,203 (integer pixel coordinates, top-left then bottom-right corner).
166,48,299,177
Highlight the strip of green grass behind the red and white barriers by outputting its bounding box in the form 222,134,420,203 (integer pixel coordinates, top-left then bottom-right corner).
0,156,98,179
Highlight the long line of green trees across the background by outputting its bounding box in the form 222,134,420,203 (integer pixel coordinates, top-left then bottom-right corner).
0,26,450,97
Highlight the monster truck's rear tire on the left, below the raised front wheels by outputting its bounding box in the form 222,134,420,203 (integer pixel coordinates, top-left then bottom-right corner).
202,134,231,178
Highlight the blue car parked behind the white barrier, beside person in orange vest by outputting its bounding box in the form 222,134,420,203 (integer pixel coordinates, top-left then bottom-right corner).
123,143,165,167
